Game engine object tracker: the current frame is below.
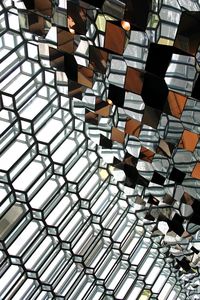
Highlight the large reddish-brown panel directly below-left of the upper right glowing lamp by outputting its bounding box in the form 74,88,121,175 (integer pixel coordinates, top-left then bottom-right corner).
104,21,126,54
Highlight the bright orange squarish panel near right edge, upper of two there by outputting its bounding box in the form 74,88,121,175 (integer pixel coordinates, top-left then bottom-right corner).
178,130,199,152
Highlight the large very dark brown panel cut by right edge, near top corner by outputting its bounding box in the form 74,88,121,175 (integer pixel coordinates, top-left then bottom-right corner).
174,11,200,55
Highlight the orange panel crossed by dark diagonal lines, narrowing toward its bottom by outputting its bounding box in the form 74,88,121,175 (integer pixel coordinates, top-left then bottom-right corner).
168,91,187,118
